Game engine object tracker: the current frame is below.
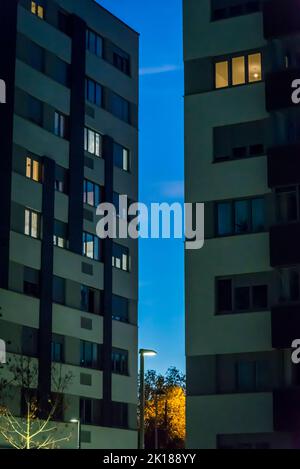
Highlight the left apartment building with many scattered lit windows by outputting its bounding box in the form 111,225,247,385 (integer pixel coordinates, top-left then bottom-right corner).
0,0,139,449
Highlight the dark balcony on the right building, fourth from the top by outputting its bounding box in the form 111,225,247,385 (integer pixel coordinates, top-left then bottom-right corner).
270,223,300,267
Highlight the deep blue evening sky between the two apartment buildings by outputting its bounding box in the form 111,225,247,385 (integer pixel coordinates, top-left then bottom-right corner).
99,0,185,372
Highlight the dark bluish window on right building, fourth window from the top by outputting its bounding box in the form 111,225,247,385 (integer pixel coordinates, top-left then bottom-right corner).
217,198,265,236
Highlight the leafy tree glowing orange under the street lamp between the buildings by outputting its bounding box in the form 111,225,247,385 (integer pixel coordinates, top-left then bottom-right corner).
145,368,185,449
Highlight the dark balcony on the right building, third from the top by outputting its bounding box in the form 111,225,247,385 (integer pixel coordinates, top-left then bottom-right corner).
268,144,300,188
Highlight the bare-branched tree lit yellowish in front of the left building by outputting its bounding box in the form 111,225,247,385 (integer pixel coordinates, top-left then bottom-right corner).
0,357,72,449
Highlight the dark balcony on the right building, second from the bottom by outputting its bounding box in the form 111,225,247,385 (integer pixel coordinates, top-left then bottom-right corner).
271,305,300,349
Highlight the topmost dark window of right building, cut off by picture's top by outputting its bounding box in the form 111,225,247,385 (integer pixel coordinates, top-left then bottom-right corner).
212,0,264,21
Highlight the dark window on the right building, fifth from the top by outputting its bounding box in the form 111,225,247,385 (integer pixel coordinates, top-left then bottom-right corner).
216,276,269,314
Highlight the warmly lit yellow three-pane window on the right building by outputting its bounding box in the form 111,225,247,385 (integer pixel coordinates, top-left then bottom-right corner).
215,52,262,89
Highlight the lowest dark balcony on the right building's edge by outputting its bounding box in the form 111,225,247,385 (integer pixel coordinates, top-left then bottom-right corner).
273,388,300,432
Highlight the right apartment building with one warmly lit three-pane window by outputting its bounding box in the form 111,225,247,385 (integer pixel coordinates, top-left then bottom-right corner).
183,0,300,449
